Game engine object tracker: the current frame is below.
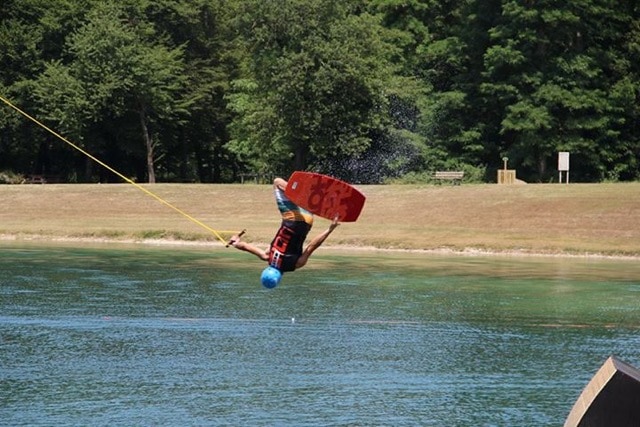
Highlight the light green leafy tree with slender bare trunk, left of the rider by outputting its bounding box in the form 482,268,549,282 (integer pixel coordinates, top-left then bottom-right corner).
69,3,190,183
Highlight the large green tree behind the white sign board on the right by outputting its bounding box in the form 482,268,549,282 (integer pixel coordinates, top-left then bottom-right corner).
482,0,633,180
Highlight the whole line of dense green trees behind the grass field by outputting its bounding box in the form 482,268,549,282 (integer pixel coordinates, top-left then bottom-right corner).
0,0,640,183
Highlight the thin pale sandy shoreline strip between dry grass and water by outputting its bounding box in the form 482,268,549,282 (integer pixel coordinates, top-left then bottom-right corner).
0,234,640,261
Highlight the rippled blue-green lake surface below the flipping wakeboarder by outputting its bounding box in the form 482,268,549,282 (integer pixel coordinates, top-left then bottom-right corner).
0,243,640,426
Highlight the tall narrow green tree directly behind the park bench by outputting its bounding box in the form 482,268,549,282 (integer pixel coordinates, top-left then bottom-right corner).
408,0,500,175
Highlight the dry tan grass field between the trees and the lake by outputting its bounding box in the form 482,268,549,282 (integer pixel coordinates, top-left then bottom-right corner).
0,183,640,256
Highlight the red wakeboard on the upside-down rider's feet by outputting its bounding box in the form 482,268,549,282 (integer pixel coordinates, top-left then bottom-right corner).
285,171,366,222
